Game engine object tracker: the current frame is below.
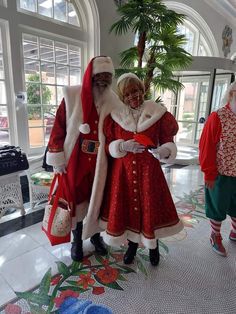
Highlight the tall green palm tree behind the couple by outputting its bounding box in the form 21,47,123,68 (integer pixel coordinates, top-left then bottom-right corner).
110,0,192,95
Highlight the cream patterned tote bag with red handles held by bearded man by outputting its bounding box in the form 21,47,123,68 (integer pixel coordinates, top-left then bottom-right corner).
42,174,72,245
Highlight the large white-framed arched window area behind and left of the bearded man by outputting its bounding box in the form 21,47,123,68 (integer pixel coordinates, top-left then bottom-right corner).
0,0,99,155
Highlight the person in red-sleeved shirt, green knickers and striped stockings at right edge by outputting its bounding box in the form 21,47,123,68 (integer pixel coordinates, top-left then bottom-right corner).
199,82,236,256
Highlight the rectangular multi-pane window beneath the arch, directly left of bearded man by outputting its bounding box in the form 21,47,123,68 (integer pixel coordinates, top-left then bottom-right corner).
23,34,81,147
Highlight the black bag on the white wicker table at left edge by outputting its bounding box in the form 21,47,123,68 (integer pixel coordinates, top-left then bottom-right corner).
0,145,29,176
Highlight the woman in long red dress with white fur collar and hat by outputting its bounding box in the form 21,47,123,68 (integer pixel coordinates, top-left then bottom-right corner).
86,73,183,266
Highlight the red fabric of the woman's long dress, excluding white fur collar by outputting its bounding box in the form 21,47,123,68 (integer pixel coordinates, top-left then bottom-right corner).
100,112,182,248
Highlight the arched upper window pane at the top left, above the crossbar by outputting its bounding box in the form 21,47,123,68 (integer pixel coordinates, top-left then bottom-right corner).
20,0,80,27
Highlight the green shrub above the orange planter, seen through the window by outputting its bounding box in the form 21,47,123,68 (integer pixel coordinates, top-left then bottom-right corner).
26,74,51,119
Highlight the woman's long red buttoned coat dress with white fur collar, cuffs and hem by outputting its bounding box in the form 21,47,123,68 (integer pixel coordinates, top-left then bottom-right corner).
99,101,183,249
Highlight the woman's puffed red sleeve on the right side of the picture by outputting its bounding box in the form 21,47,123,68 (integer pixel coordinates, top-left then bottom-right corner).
159,112,179,145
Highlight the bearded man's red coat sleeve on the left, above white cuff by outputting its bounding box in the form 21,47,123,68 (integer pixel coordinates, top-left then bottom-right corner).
48,98,66,153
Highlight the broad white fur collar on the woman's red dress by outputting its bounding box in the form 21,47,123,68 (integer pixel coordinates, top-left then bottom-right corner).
111,100,167,132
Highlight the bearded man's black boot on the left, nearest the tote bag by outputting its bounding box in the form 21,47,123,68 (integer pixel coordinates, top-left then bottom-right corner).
71,221,84,262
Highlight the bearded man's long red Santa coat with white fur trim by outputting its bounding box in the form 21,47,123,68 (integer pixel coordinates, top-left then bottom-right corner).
47,86,121,237
